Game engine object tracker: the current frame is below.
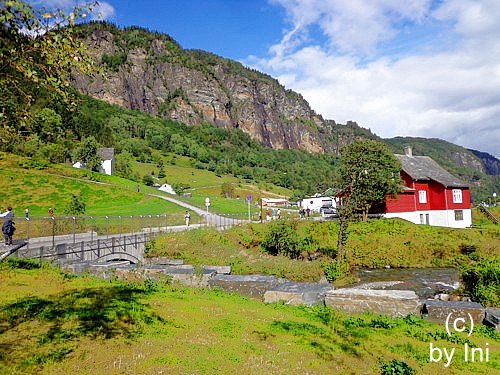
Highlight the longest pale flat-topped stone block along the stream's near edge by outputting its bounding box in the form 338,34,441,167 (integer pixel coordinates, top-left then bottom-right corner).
325,288,422,317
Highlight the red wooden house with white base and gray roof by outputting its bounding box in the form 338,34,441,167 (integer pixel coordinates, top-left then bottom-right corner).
384,147,472,228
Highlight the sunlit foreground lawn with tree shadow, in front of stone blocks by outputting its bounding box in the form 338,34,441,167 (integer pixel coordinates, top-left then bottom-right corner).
0,263,500,374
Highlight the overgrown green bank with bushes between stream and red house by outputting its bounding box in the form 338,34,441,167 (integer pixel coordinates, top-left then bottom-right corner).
148,219,500,306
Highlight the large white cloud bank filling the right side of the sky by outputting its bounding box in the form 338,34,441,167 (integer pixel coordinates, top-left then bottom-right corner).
254,0,500,157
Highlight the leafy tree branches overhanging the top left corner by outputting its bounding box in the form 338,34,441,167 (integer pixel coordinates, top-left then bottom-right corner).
0,0,95,150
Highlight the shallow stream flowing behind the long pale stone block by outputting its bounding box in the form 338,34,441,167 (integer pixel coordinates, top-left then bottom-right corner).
348,268,460,298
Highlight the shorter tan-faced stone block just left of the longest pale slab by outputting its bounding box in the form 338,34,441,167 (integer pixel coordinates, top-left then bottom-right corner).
264,282,333,306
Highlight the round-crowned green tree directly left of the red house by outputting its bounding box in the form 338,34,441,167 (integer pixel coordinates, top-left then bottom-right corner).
335,140,402,257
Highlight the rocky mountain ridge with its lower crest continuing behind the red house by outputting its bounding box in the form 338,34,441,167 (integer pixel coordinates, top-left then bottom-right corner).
73,22,500,185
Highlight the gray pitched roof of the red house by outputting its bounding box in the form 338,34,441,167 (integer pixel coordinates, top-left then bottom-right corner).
395,154,468,187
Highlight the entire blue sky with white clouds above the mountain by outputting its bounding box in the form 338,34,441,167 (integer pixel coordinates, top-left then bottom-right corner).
36,0,500,157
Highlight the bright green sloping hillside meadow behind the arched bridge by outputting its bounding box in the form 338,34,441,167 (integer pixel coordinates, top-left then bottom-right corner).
0,153,290,218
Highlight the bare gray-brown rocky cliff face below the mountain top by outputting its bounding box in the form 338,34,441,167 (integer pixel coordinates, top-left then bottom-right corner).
73,27,332,153
